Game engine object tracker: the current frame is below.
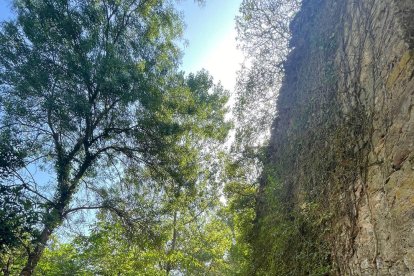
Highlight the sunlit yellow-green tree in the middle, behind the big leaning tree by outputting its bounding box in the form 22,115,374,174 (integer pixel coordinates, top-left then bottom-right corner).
68,72,231,275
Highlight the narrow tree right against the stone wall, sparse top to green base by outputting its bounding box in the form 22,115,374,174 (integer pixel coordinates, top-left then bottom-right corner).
225,0,302,275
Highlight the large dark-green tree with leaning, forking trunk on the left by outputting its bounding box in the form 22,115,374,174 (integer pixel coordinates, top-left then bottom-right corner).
0,0,225,275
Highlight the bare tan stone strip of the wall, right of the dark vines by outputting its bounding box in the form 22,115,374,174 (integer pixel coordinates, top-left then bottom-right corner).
340,0,414,275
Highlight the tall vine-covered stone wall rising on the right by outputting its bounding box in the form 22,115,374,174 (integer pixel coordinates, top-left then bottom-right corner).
254,0,414,275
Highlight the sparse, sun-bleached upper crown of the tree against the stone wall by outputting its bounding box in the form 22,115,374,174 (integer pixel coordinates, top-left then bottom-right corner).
234,0,301,152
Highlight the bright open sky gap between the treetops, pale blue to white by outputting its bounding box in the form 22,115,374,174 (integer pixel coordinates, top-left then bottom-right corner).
0,0,243,91
